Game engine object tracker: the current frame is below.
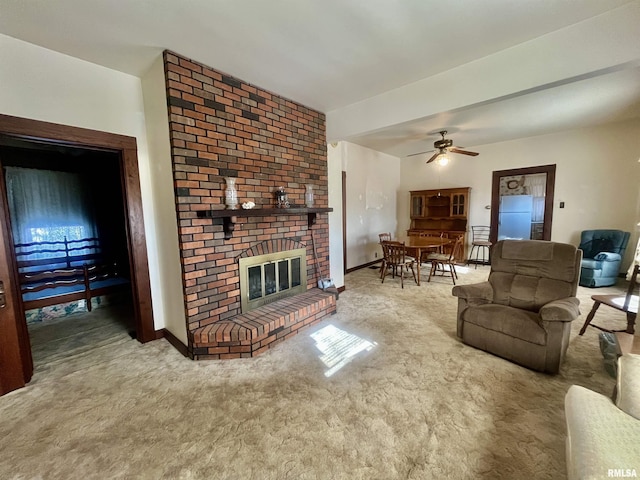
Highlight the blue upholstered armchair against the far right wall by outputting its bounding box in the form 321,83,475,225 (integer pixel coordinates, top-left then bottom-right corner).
578,230,631,287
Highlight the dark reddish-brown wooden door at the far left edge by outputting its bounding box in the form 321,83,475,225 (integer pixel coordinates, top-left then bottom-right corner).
0,158,33,395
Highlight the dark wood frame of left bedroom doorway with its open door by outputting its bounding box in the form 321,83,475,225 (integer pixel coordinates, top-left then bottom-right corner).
0,115,158,395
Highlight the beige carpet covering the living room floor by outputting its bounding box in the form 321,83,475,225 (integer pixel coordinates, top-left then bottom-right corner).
0,267,624,480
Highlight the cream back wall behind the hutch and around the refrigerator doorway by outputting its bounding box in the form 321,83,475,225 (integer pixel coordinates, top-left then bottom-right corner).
398,121,640,269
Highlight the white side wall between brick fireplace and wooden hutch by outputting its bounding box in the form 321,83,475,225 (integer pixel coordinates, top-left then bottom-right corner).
340,142,400,268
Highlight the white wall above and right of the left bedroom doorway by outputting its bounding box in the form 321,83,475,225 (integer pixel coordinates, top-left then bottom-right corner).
0,35,177,329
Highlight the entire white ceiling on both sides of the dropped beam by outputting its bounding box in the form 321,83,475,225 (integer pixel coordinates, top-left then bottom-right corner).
0,0,640,157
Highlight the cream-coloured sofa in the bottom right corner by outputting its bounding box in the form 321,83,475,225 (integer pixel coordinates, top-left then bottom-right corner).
564,354,640,480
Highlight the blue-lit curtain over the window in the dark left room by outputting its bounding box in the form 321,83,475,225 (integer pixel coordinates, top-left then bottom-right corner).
6,167,97,256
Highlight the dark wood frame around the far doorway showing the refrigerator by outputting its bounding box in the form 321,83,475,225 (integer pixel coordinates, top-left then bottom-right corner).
489,165,556,243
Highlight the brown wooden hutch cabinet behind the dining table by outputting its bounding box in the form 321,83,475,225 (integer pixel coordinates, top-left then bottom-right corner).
407,187,471,263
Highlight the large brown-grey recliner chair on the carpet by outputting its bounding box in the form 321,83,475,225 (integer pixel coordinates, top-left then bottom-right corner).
452,240,582,373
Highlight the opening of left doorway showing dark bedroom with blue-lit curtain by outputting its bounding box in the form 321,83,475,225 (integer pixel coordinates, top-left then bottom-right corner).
0,139,136,370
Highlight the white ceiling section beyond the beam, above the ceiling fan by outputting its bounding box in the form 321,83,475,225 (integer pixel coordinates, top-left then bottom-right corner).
349,63,640,158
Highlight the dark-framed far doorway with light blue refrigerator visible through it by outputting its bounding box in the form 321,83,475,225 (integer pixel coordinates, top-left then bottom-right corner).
490,165,556,243
